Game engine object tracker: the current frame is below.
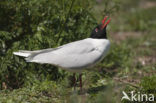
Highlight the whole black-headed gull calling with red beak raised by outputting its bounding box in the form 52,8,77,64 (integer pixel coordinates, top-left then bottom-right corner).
13,16,110,89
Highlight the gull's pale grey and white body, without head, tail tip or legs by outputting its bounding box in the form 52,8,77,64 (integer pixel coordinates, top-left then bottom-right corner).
27,38,110,71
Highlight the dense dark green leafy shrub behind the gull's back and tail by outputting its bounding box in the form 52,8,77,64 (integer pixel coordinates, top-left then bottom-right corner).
0,0,95,89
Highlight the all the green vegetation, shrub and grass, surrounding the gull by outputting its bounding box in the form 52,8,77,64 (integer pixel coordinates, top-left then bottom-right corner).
0,0,156,103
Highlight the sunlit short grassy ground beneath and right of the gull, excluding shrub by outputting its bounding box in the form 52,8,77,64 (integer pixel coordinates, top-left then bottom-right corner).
0,1,156,103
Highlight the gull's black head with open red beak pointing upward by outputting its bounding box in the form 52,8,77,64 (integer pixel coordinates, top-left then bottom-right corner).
90,16,110,39
